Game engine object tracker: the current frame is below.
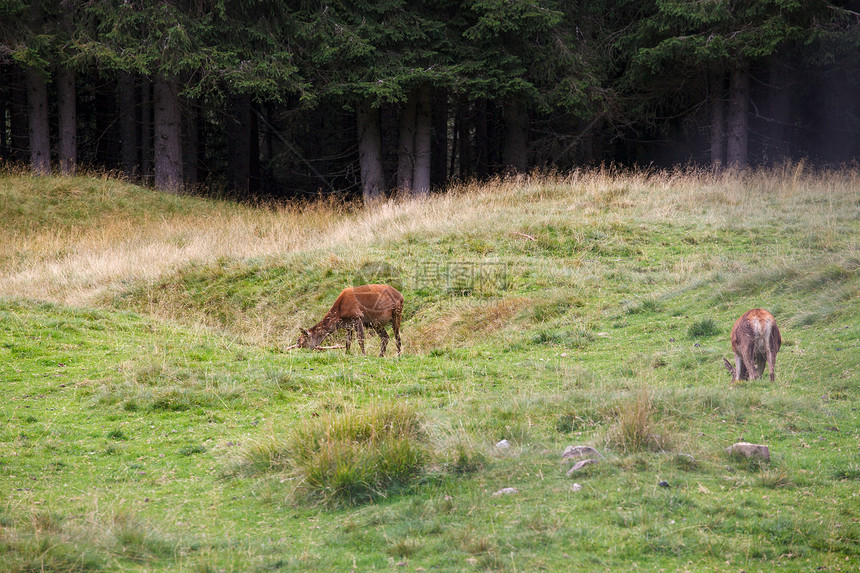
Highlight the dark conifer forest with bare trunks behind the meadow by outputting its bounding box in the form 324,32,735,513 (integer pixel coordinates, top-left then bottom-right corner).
0,0,860,203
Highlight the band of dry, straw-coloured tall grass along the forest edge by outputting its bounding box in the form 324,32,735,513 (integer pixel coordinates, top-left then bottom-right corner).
0,164,860,305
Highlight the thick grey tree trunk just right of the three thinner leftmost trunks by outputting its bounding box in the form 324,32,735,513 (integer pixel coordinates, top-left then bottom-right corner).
154,77,182,193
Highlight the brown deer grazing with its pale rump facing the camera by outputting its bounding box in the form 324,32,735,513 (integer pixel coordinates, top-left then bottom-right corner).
723,308,782,382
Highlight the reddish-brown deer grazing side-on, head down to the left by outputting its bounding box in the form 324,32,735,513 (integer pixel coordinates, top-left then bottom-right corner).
290,284,403,356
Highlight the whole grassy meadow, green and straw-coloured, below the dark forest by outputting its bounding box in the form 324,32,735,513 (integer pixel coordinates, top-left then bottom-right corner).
0,164,860,572
